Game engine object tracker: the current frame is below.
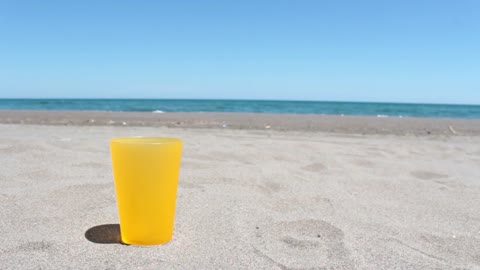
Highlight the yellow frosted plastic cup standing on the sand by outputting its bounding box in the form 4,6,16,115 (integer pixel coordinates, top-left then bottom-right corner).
110,137,182,245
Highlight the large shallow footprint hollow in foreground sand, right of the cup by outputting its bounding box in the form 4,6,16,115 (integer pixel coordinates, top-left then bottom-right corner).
255,219,353,269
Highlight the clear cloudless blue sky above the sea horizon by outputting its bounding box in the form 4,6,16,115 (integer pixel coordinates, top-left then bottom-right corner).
0,0,480,104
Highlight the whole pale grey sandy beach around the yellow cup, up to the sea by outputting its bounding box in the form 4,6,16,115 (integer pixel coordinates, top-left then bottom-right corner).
0,111,480,270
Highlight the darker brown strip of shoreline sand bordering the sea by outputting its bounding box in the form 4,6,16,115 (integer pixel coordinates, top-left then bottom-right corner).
0,110,480,136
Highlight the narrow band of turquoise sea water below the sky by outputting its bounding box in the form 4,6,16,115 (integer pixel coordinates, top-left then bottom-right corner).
0,99,480,118
